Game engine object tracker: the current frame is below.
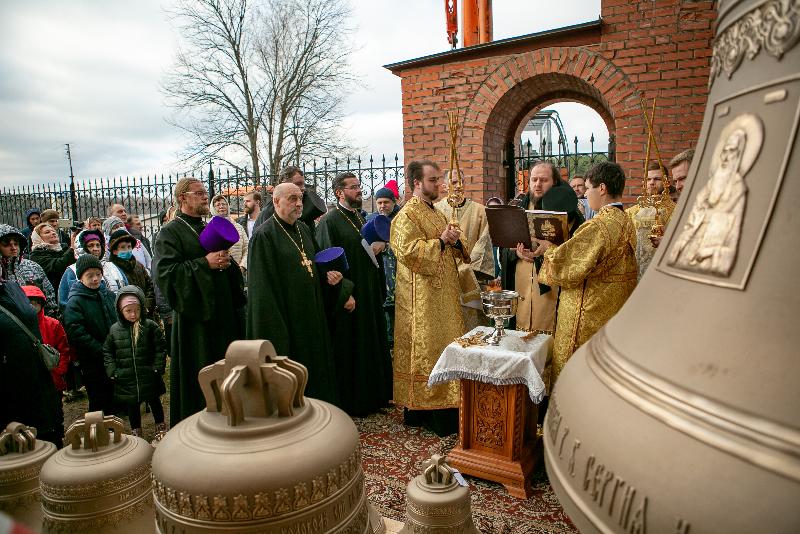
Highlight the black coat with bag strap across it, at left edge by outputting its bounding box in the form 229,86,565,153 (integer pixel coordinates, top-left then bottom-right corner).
0,281,64,440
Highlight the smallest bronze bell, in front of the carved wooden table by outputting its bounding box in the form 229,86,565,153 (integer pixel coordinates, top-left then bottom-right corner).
400,454,480,534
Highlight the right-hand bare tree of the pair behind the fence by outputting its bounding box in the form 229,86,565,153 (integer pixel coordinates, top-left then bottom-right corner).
259,0,354,178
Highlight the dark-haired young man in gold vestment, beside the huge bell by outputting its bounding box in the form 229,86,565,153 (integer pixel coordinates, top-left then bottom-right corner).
534,162,638,385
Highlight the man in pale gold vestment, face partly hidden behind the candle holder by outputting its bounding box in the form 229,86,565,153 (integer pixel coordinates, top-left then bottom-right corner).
434,171,494,332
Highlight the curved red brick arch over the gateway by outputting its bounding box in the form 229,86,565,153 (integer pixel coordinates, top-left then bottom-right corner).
461,47,640,197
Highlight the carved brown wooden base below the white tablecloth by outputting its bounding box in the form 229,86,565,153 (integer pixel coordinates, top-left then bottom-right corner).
447,380,538,499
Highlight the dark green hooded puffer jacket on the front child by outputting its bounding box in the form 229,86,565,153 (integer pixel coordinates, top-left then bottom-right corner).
103,286,166,404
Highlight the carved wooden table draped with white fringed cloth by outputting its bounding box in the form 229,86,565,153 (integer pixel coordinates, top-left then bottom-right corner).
429,327,552,498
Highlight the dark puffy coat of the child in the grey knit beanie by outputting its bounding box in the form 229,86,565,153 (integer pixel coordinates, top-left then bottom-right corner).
64,281,117,380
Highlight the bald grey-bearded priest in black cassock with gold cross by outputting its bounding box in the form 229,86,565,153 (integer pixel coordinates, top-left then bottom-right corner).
247,183,340,404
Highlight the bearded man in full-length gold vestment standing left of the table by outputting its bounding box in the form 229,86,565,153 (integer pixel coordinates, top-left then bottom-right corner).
390,161,464,417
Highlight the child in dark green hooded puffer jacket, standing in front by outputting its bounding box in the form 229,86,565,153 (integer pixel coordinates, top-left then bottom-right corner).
103,285,167,437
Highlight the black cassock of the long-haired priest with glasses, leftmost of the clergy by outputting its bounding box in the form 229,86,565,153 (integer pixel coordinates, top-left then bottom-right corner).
153,213,245,426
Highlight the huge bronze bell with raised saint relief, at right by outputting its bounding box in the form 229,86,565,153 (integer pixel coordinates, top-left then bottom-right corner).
544,0,800,534
